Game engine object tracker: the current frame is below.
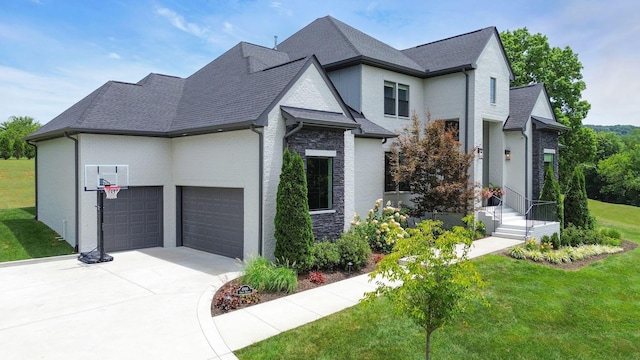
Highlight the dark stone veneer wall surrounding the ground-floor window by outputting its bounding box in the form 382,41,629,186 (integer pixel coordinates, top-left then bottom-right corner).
287,127,345,241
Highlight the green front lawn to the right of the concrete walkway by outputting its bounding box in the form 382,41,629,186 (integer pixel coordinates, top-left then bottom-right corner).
235,201,640,360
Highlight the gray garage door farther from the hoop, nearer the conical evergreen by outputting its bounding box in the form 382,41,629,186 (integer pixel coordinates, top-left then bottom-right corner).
182,187,244,259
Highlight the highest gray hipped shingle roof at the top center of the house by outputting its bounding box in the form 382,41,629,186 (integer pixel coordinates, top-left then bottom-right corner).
278,16,424,75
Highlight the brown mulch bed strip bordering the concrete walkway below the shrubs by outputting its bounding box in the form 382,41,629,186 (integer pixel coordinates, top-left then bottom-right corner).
211,253,379,316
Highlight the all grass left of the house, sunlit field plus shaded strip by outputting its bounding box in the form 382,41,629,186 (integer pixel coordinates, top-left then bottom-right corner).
0,159,73,262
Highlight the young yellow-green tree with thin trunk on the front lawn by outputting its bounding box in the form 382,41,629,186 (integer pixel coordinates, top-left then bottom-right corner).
364,220,484,359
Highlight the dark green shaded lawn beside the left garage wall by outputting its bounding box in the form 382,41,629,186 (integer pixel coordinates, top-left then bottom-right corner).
0,208,73,262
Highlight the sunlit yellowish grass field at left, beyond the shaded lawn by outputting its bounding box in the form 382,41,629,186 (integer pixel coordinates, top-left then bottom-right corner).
0,159,35,209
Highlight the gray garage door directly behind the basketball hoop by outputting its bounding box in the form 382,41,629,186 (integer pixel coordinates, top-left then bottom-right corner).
103,186,162,251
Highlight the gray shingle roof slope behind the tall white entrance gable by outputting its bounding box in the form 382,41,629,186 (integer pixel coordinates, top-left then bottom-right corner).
402,26,513,77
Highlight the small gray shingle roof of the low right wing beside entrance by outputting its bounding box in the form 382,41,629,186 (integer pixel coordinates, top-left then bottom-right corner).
503,84,566,131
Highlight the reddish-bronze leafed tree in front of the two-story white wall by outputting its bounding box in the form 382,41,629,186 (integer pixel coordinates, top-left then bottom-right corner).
391,112,474,216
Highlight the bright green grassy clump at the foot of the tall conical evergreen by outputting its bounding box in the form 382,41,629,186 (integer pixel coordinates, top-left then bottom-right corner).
242,256,298,293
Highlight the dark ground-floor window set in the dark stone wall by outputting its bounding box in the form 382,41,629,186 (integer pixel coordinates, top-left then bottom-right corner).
307,157,333,211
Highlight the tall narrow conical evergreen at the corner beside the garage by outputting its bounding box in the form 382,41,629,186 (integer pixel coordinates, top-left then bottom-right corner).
274,148,314,271
